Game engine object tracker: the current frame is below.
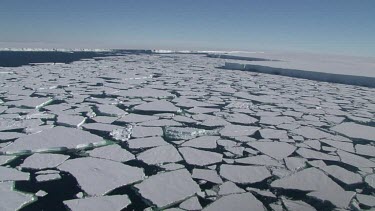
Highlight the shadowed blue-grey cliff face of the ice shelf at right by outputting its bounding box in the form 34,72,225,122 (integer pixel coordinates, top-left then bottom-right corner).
222,62,375,88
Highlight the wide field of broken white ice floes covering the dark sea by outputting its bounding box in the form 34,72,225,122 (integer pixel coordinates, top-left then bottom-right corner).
0,52,375,211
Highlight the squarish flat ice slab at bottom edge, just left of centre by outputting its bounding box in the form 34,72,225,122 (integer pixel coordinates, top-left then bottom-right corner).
135,169,200,208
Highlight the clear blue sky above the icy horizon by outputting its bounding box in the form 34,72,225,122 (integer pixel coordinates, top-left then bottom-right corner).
0,0,375,56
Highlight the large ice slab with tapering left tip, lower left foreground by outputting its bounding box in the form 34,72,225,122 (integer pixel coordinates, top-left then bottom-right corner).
58,158,144,196
